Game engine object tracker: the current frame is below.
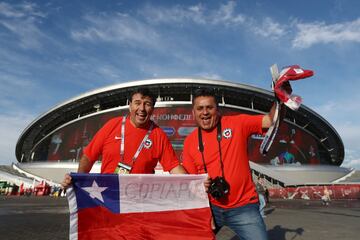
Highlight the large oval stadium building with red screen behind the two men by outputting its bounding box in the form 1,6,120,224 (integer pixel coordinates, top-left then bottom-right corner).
15,78,353,186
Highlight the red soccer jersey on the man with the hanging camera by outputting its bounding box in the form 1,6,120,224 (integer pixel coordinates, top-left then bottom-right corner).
182,114,263,208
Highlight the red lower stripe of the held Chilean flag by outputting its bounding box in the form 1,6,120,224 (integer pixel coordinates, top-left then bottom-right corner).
78,207,215,240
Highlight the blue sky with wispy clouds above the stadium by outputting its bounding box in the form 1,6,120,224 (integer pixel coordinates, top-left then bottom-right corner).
0,0,360,169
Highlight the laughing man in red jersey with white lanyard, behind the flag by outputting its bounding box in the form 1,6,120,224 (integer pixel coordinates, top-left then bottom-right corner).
62,88,186,188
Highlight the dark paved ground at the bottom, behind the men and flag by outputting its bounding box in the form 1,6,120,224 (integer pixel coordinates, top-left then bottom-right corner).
0,196,360,240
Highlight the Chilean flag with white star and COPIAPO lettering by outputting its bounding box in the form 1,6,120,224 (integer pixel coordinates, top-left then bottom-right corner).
67,174,215,240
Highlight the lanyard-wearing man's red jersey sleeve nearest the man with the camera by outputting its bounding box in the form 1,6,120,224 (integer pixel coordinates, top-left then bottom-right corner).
158,128,180,172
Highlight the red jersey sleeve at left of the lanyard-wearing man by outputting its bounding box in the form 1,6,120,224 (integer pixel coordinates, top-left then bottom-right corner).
83,118,121,163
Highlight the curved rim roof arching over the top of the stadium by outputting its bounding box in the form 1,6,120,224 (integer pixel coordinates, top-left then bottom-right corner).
16,78,344,166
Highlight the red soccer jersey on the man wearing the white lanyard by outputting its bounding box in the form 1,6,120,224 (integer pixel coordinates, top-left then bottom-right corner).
84,117,179,173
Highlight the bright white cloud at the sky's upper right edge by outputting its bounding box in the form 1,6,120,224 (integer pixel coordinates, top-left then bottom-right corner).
292,18,360,48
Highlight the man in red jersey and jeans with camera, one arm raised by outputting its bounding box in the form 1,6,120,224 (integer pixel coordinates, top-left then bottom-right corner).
182,88,275,240
